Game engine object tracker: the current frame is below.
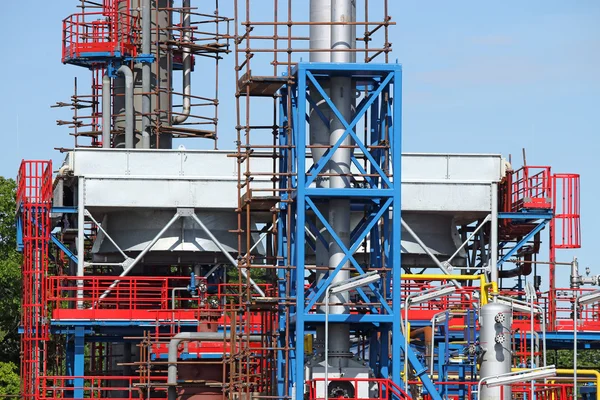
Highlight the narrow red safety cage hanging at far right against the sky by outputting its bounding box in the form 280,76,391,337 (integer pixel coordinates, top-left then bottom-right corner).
552,174,581,249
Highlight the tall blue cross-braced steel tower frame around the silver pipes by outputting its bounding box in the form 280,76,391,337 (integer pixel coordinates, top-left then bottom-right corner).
280,63,440,400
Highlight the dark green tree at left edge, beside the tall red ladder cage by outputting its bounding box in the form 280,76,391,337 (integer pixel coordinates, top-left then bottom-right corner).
0,177,21,366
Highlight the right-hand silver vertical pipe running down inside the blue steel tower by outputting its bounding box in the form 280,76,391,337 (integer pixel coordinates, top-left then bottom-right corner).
326,0,356,368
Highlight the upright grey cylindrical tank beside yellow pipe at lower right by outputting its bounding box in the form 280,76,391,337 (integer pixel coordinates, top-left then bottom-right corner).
479,303,512,400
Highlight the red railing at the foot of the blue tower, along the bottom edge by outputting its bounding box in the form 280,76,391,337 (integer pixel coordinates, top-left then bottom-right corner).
306,378,411,400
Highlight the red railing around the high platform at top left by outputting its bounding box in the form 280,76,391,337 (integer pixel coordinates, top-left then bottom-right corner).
62,0,137,63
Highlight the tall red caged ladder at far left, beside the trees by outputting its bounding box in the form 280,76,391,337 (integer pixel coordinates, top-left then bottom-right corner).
17,161,52,399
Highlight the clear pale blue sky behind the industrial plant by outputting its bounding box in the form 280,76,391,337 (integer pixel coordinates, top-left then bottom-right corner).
0,0,600,285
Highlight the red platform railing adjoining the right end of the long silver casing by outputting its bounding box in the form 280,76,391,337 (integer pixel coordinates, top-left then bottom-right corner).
504,166,552,212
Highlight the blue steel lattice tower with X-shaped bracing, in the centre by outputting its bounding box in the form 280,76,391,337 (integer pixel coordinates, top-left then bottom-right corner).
278,62,436,400
